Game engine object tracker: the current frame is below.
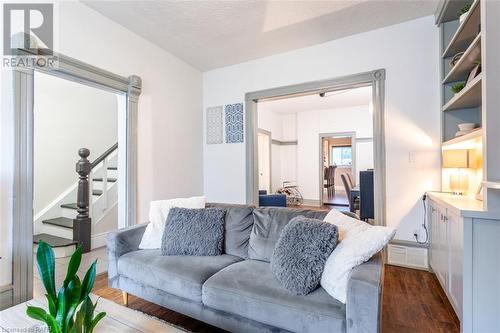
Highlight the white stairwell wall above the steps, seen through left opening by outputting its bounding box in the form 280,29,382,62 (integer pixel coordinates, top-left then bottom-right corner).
33,73,118,215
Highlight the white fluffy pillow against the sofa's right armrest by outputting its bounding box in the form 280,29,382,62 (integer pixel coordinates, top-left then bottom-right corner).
321,210,396,304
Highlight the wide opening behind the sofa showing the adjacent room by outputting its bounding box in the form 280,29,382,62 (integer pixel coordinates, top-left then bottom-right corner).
247,70,385,220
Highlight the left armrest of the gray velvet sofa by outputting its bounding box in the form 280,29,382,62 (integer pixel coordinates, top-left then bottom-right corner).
106,223,148,288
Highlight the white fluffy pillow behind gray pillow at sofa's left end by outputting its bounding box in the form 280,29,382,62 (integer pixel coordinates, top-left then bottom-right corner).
139,197,205,250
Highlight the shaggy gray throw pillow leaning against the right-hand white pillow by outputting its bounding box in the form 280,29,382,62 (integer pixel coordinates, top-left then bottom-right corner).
271,216,338,295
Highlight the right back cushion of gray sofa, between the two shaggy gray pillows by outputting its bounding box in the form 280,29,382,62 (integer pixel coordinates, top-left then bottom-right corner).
248,207,328,262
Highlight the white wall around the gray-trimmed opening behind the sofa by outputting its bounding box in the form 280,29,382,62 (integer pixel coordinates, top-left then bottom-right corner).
203,16,440,240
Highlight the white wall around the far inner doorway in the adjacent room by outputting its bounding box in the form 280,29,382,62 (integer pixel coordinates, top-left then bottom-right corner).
297,105,373,202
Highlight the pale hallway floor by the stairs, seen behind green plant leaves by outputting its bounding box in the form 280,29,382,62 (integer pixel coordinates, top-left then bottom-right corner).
33,247,108,298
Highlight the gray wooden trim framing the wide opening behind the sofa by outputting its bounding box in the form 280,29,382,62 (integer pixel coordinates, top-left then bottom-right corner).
245,69,386,225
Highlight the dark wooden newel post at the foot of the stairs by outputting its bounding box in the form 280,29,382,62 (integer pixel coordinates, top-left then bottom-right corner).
73,148,92,253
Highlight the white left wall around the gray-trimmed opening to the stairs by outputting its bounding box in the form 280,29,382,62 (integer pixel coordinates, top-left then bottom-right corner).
0,2,203,282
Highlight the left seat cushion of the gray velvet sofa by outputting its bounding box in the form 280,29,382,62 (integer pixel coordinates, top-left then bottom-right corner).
118,250,241,302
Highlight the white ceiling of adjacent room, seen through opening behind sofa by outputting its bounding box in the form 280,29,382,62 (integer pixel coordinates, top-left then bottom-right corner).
258,87,372,113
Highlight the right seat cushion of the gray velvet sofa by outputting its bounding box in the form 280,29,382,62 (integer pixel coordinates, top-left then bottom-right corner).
203,260,346,332
